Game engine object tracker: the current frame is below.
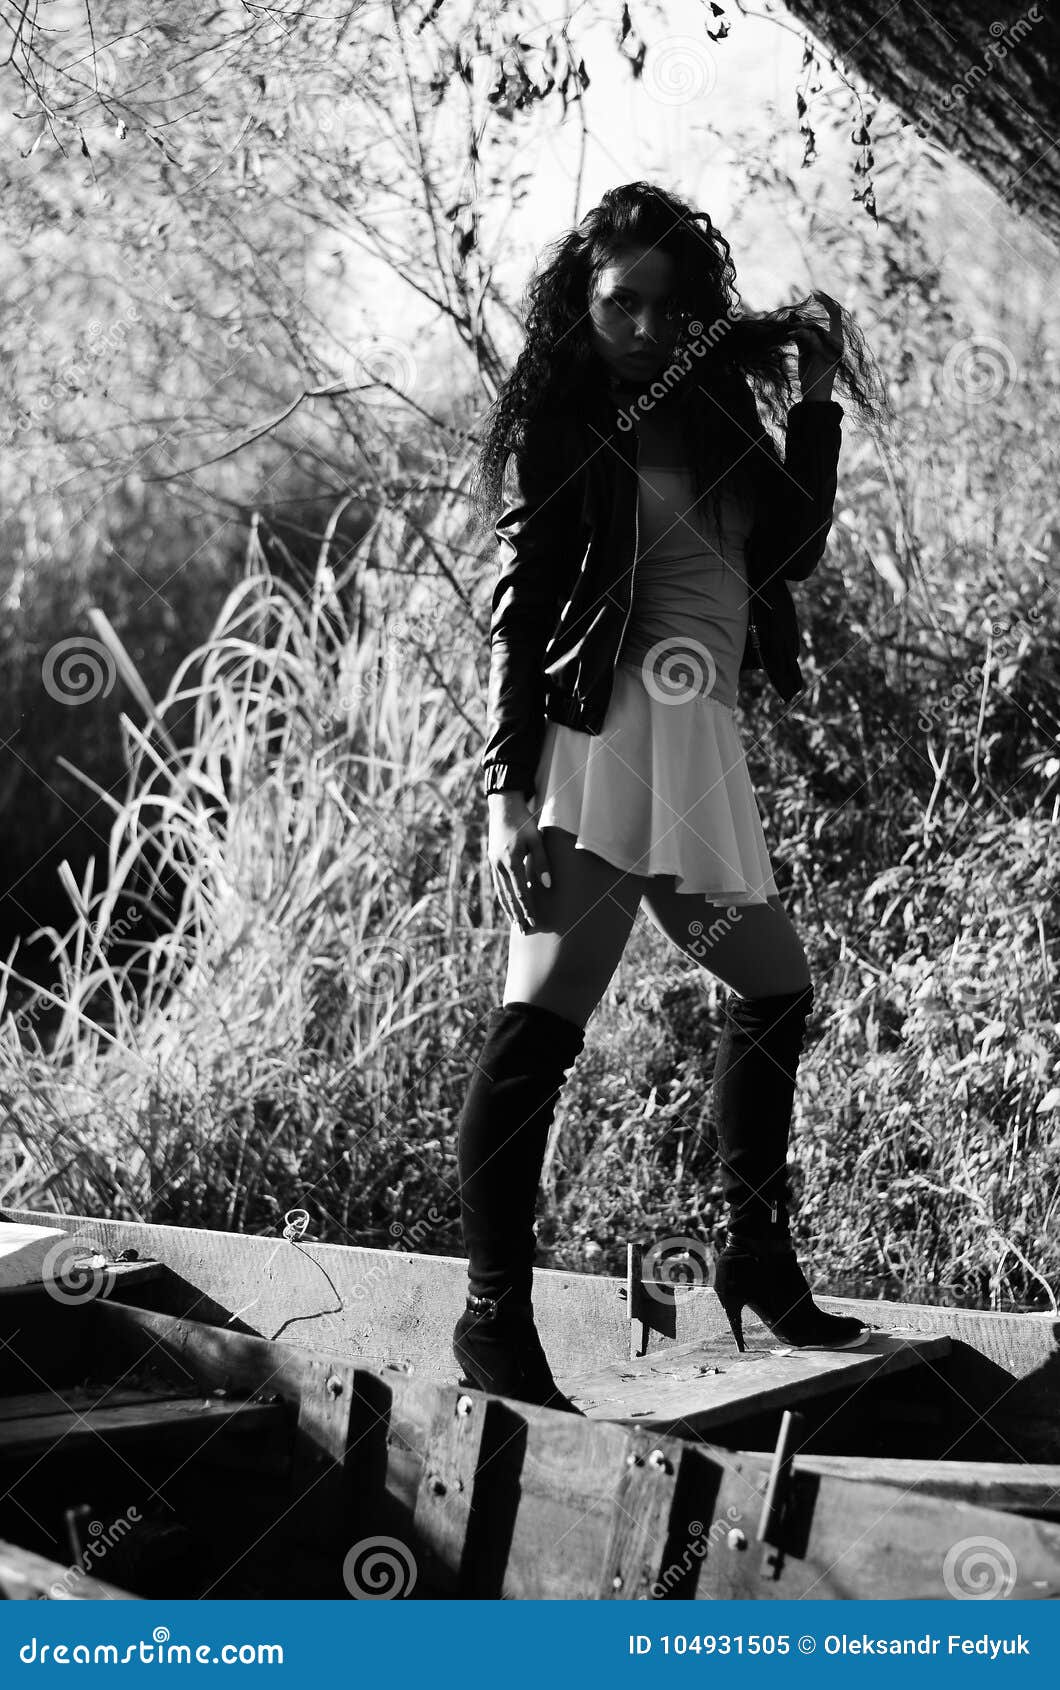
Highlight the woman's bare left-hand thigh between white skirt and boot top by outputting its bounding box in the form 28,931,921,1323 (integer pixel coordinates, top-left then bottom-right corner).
504,826,649,1028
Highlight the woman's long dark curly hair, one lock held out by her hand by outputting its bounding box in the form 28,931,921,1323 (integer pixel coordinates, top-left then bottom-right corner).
468,181,893,529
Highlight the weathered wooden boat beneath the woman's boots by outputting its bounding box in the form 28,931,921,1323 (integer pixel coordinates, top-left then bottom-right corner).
0,1212,1060,1599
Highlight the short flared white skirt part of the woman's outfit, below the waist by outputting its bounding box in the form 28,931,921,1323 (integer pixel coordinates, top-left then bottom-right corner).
531,662,776,904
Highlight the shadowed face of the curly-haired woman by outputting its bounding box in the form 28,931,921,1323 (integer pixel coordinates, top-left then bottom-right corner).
588,247,680,382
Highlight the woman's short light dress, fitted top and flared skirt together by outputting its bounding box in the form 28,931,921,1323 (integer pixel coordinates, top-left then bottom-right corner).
531,453,776,904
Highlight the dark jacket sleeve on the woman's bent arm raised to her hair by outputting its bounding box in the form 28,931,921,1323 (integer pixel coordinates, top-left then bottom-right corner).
720,382,844,581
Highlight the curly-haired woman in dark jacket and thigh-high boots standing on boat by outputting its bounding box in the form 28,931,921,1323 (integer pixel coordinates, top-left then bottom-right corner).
453,183,882,1413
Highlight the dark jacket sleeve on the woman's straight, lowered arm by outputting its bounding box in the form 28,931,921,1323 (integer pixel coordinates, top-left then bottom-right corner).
482,417,585,798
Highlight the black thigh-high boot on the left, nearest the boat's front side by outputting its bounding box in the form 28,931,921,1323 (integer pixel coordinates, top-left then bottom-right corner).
453,1002,585,1413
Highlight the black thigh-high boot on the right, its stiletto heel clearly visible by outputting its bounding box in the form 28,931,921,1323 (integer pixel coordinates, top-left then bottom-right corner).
713,985,866,1350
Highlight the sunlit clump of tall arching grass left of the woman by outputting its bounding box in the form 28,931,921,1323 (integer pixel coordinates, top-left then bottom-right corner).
0,520,499,1237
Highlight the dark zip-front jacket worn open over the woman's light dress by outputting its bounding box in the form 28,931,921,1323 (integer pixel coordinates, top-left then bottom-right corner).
482,377,844,798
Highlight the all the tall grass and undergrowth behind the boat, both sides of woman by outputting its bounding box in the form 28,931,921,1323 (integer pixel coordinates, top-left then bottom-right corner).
0,476,1060,1308
